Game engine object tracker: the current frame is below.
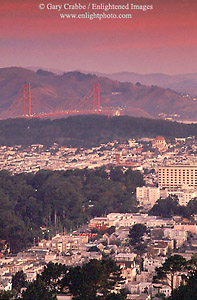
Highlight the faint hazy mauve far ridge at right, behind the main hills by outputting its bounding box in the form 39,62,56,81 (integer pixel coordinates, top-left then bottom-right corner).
95,72,197,97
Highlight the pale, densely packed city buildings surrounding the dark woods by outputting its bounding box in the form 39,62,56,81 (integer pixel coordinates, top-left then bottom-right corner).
0,137,197,300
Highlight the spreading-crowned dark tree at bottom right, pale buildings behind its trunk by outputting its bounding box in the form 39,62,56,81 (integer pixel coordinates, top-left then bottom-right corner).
153,255,187,293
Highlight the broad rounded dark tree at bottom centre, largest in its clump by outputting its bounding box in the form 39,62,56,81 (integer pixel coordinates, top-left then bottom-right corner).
62,259,122,300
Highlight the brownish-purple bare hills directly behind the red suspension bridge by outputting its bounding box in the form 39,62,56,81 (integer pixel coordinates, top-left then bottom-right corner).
0,67,197,119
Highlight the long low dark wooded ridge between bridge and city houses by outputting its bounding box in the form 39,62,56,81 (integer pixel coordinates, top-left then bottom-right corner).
0,115,197,147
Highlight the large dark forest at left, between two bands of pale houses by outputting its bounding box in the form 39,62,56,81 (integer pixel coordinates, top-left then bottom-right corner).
0,168,143,252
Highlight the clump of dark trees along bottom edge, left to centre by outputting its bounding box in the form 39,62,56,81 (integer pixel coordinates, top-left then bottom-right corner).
22,259,125,300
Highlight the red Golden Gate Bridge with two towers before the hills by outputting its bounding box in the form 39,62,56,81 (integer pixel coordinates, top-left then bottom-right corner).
4,82,120,119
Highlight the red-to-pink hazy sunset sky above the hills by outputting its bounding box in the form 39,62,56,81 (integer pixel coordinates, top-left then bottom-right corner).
0,0,197,74
